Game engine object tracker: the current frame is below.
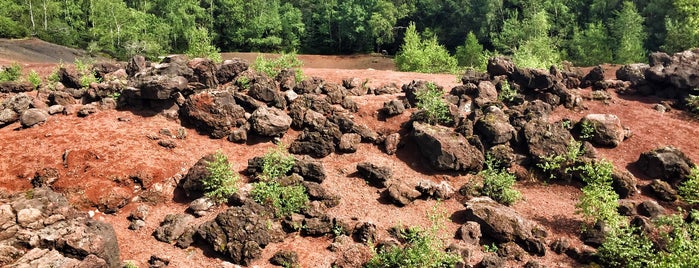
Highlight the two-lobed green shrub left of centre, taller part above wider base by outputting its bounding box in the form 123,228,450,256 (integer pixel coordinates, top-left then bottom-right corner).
250,143,309,217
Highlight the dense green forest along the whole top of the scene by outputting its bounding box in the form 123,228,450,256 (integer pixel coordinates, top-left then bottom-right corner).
0,0,699,66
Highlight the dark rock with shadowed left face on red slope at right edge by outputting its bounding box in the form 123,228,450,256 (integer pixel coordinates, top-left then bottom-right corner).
636,146,695,184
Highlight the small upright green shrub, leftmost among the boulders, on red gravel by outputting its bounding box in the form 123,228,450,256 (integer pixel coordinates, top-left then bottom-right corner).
202,151,239,203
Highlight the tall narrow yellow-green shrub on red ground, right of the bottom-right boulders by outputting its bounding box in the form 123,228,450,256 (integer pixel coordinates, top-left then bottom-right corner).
571,160,622,227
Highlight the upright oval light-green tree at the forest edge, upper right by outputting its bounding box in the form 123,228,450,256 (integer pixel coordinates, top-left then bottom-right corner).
610,1,646,64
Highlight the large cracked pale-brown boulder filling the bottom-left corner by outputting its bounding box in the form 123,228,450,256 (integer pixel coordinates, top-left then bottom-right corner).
0,188,121,268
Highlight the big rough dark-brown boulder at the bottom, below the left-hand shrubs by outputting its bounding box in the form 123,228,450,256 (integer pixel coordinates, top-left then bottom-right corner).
197,201,280,265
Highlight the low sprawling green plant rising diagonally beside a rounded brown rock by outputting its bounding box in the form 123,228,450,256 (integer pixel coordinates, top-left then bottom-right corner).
536,139,585,180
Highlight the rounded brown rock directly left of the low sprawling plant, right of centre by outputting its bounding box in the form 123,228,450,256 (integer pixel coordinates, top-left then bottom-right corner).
523,119,573,160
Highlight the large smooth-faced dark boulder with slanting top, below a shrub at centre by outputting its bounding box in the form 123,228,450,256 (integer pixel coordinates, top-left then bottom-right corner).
413,122,485,172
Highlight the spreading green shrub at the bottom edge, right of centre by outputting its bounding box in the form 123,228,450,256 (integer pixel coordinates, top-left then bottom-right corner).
365,206,461,268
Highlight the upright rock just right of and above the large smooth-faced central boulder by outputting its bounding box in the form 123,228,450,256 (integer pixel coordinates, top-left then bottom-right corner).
474,106,516,146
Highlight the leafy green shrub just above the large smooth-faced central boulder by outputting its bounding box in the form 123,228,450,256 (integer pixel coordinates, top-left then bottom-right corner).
415,82,452,124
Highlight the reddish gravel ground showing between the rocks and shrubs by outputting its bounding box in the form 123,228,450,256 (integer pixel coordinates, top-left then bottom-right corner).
0,39,699,267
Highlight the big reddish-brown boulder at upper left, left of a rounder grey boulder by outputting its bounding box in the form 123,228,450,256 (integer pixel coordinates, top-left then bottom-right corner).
181,91,245,139
